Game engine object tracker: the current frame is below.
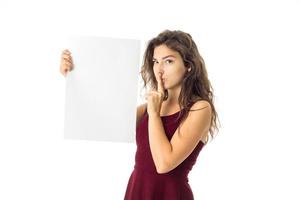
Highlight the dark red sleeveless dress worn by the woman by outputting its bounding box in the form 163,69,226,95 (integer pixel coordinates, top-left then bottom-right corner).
124,105,204,200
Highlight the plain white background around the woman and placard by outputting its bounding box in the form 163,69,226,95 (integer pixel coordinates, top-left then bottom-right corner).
0,0,300,200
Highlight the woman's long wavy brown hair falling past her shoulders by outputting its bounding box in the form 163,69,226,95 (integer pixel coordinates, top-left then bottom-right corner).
140,30,219,144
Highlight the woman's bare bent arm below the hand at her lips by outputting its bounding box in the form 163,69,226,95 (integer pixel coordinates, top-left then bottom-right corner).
148,101,211,173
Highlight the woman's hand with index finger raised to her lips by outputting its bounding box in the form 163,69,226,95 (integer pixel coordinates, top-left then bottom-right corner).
146,73,165,116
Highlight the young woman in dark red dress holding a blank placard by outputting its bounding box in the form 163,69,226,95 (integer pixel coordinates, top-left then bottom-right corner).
60,30,218,200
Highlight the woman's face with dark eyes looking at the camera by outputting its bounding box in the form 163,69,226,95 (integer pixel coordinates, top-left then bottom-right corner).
153,44,187,89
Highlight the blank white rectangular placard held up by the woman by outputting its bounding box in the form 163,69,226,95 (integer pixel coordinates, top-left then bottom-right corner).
64,36,140,142
